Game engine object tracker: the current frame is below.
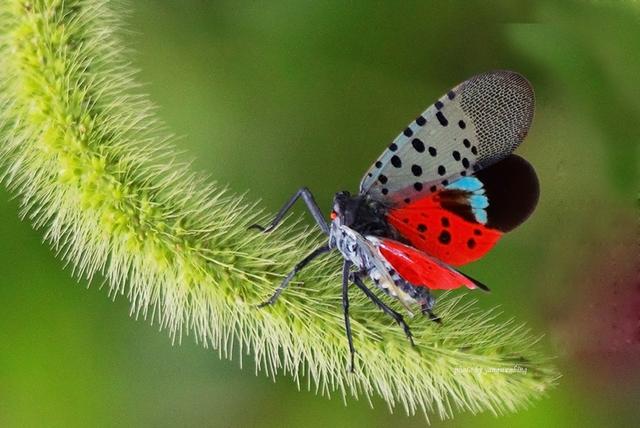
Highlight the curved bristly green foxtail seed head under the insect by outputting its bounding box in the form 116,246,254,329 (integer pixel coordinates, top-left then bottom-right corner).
0,0,558,418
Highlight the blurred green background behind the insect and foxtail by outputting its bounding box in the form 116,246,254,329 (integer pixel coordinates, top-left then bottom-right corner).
0,0,640,427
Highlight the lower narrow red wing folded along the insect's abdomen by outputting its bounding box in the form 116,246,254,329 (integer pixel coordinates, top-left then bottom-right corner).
367,237,487,290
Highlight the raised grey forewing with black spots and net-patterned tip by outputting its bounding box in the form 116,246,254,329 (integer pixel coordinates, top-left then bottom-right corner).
360,71,535,205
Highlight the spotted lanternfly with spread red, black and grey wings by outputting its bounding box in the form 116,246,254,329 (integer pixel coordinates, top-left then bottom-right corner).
251,70,539,370
